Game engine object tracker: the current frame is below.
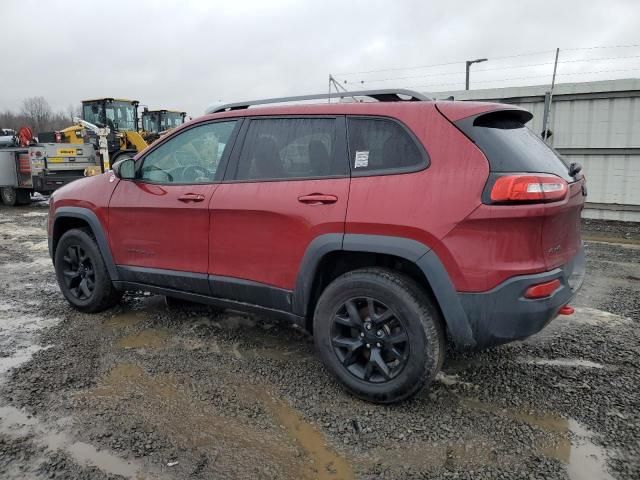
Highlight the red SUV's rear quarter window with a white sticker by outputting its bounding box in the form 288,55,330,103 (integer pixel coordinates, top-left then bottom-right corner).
348,118,424,174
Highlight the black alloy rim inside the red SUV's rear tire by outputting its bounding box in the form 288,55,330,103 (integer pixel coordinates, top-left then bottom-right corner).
331,297,409,383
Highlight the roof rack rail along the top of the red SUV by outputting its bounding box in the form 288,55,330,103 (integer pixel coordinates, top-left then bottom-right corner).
205,88,432,114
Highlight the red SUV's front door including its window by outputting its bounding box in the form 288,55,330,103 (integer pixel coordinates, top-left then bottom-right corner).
109,120,239,293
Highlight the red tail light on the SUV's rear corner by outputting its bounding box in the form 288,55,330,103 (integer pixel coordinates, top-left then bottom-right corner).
491,174,569,202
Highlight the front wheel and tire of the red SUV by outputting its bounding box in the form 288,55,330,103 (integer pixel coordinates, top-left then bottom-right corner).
54,229,122,313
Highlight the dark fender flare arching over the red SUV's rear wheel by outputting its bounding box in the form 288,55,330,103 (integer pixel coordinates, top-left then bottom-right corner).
292,233,476,348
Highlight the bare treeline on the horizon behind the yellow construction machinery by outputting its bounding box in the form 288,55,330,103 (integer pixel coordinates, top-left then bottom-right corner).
0,97,80,135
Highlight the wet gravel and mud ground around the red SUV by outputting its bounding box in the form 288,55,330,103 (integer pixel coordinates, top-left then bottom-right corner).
0,201,640,480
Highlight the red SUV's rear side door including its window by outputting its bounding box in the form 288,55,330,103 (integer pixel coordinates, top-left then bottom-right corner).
209,117,349,310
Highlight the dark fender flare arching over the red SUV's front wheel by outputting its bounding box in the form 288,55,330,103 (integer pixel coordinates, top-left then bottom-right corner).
50,207,119,280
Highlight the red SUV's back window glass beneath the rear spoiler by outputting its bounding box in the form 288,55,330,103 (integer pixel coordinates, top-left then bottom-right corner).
456,110,573,182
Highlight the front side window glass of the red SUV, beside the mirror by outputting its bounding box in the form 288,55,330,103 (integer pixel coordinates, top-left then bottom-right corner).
139,120,236,183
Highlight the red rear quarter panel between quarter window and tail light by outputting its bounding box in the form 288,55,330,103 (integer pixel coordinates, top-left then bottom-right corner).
346,104,489,249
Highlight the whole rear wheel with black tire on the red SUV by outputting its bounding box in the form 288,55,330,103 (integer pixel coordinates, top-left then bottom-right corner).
313,268,445,404
